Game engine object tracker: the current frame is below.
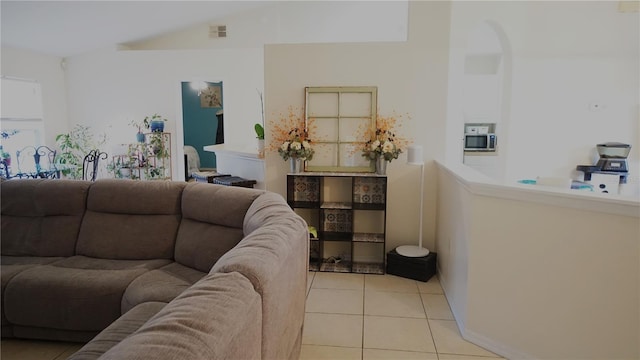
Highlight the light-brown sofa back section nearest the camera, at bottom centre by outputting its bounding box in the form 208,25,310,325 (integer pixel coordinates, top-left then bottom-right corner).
100,273,262,360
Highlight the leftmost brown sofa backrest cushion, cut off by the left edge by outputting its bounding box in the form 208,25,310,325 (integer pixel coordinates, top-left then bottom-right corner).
0,179,91,256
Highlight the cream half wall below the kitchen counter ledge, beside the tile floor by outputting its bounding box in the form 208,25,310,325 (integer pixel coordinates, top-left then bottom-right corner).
436,165,640,359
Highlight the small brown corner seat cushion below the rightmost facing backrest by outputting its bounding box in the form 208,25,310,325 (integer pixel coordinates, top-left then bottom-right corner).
122,262,207,313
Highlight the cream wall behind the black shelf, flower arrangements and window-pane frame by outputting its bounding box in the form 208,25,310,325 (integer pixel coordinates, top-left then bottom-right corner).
265,2,449,250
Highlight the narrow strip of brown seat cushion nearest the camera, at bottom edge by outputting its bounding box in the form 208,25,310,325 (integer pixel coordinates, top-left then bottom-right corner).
67,302,167,360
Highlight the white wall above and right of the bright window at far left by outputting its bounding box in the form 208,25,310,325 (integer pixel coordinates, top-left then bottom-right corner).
1,47,68,146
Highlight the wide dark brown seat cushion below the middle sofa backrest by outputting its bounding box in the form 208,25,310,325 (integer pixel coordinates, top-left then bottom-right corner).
4,256,169,331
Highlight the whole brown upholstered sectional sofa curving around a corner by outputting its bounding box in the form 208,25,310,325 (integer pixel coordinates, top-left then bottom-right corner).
0,179,308,359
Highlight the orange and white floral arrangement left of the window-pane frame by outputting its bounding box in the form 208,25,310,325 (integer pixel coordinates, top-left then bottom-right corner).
269,106,315,160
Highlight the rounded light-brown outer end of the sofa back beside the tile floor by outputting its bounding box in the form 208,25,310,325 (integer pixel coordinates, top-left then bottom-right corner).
211,193,309,359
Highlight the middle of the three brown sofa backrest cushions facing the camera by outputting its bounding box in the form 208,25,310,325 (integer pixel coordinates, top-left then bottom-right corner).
76,179,186,260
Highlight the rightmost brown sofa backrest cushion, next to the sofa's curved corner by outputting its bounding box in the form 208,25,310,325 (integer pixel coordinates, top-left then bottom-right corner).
175,183,264,272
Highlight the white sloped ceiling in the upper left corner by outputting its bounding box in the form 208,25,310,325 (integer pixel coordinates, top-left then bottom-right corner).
0,0,272,57
